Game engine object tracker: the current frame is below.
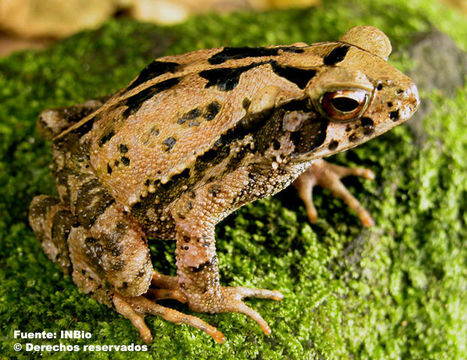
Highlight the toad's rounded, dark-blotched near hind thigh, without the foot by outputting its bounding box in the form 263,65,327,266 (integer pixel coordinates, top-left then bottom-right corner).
68,203,154,303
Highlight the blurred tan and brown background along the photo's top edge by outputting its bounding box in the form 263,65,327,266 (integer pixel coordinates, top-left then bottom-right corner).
0,0,467,56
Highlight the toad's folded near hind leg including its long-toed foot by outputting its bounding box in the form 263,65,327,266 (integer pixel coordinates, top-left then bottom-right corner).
29,195,224,342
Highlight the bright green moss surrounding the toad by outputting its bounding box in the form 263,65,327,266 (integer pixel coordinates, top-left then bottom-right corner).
0,0,467,359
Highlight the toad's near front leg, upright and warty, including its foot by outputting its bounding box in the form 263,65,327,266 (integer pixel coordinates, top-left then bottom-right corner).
172,172,283,334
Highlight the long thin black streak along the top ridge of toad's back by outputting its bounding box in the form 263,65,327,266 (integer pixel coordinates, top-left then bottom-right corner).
208,46,304,65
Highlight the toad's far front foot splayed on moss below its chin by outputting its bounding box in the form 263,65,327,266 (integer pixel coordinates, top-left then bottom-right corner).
293,159,375,226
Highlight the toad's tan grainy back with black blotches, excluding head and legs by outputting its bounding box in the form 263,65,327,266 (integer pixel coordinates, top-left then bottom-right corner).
67,43,336,205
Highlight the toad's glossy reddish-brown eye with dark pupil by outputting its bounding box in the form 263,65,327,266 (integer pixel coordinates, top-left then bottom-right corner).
321,90,369,121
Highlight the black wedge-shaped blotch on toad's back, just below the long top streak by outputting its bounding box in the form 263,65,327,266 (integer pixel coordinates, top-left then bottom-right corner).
199,61,269,91
